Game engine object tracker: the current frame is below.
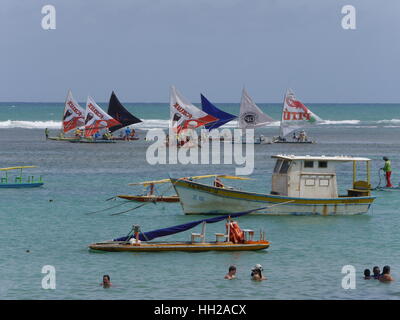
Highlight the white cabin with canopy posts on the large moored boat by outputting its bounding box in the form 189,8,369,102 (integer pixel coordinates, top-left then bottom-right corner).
271,155,371,199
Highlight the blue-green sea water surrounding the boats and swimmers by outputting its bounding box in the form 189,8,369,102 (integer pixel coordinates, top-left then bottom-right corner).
0,102,400,300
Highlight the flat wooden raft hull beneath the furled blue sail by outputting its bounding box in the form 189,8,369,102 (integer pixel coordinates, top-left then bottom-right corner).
89,241,270,252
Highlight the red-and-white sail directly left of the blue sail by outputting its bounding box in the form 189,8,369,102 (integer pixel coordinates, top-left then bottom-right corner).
170,87,218,133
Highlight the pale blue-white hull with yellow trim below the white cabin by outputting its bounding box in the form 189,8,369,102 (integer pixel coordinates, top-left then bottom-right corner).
171,178,375,216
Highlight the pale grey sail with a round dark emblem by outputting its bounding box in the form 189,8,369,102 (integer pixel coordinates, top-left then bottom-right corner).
239,88,274,129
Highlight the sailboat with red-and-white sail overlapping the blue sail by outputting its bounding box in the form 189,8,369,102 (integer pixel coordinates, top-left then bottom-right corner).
168,86,219,146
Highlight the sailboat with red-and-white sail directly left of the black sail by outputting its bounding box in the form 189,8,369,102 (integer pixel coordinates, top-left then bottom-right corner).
70,96,121,143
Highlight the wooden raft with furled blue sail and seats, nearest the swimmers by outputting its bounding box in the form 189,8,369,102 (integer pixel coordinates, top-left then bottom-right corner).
89,210,270,252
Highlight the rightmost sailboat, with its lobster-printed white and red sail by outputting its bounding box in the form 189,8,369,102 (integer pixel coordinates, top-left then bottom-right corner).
274,89,322,143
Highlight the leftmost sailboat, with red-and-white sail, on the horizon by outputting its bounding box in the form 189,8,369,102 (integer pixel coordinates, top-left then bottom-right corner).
46,90,85,141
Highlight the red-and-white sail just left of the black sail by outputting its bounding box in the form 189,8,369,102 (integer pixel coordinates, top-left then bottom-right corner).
85,96,121,137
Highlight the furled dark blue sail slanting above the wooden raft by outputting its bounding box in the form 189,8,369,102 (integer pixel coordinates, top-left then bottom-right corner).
113,208,265,241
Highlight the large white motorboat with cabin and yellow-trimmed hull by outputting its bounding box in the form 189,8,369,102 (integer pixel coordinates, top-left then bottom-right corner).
171,155,375,215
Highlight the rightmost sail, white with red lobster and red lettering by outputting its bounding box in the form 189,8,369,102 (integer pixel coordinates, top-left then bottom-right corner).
280,89,322,138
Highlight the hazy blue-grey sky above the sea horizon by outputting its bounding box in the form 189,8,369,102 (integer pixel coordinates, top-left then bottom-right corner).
0,0,400,103
